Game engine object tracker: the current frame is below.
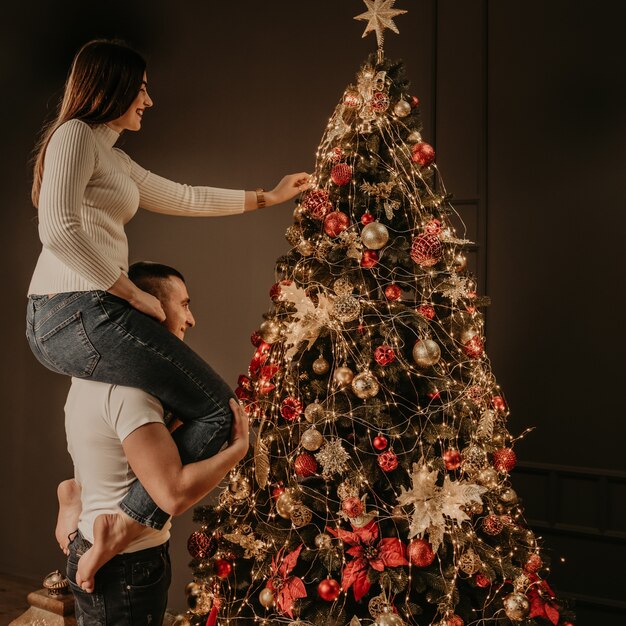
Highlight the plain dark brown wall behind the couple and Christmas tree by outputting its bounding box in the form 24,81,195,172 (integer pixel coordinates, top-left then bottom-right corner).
0,0,626,624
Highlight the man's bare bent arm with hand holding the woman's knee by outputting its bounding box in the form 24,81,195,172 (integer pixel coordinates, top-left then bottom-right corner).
122,399,249,515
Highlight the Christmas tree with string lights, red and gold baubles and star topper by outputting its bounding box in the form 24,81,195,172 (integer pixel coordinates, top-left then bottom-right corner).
179,0,573,626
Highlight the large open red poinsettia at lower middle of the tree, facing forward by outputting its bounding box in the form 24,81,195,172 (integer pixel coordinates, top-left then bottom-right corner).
326,520,409,600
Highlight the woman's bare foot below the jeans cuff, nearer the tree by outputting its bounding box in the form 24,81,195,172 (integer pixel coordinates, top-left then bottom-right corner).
76,513,146,593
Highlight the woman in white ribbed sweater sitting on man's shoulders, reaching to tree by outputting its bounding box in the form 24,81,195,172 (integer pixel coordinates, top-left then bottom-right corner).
26,40,309,584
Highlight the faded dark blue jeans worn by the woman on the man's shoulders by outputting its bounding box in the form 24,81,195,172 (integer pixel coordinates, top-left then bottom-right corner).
26,291,234,529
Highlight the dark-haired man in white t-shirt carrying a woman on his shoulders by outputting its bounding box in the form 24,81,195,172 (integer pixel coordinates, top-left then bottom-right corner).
56,263,248,625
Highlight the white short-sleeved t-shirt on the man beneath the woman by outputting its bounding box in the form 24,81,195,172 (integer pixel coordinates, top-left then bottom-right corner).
65,378,171,552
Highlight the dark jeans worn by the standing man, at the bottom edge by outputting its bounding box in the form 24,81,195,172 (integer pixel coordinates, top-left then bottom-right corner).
67,532,172,626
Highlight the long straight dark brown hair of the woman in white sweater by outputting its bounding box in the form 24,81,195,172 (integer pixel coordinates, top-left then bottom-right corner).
31,39,146,206
